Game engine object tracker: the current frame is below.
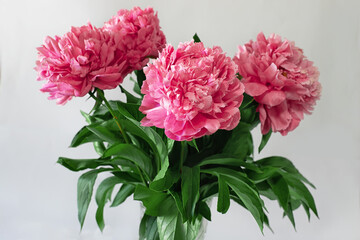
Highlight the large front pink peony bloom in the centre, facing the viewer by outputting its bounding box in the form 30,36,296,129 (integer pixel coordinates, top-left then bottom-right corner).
140,42,244,141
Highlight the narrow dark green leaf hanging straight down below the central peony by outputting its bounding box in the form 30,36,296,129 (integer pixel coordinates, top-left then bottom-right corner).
181,166,200,221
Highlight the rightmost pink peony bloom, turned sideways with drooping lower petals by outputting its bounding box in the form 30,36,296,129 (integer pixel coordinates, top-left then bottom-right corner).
234,33,321,135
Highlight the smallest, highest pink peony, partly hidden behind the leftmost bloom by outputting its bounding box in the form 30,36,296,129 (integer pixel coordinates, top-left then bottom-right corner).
103,7,166,70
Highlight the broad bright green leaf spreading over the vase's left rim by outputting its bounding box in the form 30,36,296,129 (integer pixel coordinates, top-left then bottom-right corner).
134,185,176,216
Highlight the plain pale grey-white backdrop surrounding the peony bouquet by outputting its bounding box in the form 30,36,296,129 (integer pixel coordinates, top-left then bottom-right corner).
0,0,360,240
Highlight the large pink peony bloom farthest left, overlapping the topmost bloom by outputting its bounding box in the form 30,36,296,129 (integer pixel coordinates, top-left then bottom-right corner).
35,24,129,104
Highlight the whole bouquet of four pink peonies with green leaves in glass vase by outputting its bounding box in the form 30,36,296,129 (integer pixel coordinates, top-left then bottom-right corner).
35,7,321,240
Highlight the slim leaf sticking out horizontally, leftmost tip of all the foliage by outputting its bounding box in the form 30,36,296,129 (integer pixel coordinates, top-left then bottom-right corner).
57,157,103,172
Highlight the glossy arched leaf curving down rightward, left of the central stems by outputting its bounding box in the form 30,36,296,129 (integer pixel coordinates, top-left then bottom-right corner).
103,143,153,180
